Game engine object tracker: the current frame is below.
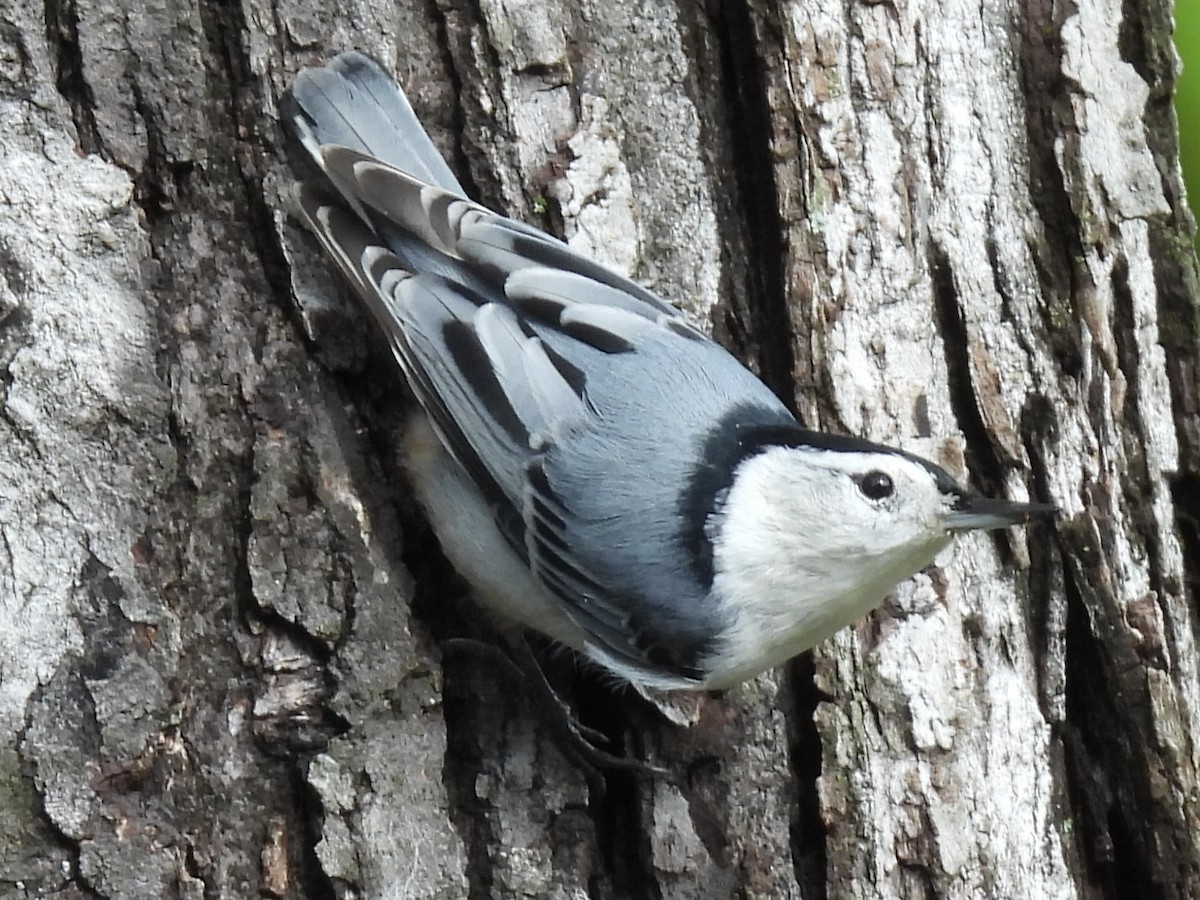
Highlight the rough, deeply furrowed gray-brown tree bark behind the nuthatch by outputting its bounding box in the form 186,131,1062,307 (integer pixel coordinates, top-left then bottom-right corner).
0,0,1200,900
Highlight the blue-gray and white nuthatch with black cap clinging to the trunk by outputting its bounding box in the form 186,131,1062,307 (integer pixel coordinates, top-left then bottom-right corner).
280,53,1052,690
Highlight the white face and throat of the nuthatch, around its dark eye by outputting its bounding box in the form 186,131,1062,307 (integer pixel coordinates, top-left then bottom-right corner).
710,446,955,683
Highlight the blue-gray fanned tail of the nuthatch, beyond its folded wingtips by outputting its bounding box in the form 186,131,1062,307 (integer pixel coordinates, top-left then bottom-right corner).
292,50,466,196
